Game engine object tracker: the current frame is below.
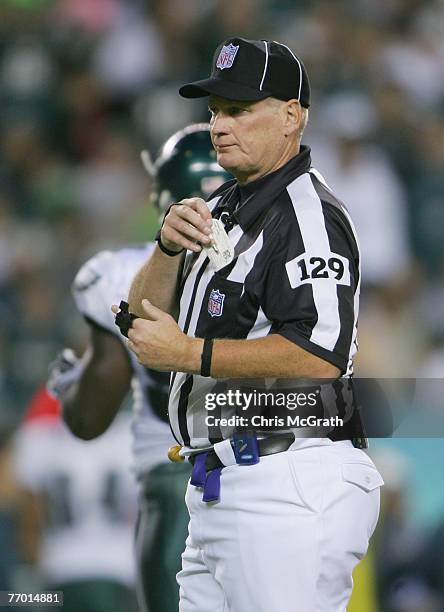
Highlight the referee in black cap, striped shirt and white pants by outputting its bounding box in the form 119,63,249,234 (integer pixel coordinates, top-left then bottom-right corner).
123,38,382,612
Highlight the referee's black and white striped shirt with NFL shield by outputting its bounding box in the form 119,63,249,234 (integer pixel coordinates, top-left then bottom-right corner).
169,146,360,448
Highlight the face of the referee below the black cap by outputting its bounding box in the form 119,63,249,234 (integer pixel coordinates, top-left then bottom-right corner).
208,96,299,184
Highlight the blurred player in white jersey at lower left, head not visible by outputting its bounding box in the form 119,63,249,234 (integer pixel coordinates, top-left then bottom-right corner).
13,388,137,612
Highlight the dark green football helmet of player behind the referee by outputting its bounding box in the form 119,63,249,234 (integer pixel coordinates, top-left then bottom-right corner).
144,123,233,214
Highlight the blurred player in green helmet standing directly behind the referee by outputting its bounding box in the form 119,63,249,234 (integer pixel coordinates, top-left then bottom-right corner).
48,124,231,612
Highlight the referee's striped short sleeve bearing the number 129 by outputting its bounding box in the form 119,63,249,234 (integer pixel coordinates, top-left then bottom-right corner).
261,201,359,373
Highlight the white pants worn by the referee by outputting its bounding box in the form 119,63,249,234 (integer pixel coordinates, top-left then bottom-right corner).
177,441,383,612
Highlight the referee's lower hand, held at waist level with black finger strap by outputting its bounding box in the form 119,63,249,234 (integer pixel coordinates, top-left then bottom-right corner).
128,300,201,372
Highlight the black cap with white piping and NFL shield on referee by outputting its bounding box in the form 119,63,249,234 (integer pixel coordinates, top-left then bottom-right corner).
179,37,310,108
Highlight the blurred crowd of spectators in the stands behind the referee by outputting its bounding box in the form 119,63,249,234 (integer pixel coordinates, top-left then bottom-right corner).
0,0,444,611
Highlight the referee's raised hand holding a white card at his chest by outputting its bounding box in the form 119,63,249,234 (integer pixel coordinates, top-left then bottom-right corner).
160,198,212,253
